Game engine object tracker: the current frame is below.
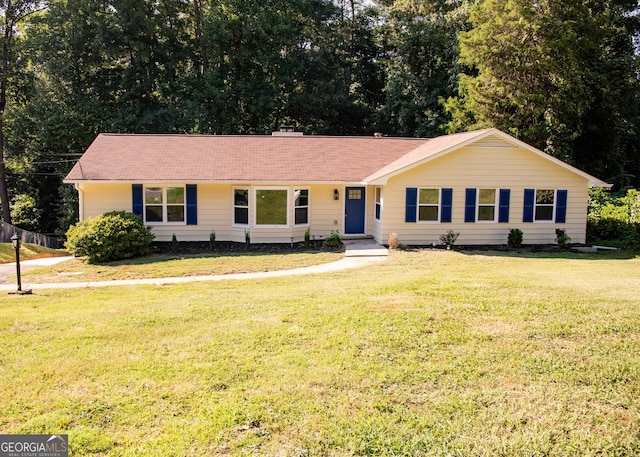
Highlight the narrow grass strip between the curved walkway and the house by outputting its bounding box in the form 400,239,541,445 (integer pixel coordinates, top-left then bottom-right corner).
4,251,343,284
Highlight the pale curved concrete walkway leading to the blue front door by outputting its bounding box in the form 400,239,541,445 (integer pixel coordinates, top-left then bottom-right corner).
0,240,389,291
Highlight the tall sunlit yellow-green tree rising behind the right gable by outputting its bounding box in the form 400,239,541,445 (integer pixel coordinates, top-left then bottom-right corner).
448,0,638,186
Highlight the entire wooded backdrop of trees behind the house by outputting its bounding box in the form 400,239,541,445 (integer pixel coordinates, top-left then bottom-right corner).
0,0,640,232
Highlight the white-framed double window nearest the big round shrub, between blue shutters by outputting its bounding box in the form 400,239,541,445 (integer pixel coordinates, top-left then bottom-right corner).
144,183,185,224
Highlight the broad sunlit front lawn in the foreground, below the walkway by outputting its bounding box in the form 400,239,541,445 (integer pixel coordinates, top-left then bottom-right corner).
0,250,640,457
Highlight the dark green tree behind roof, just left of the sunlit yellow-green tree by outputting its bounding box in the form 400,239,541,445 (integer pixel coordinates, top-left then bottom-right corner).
379,0,469,136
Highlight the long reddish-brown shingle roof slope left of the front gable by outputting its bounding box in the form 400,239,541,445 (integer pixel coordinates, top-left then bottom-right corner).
66,134,436,182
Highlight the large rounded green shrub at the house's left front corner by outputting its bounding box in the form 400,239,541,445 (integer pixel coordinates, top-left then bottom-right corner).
65,211,154,263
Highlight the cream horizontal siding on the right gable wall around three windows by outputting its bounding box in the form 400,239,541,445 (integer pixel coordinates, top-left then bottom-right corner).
376,140,588,245
